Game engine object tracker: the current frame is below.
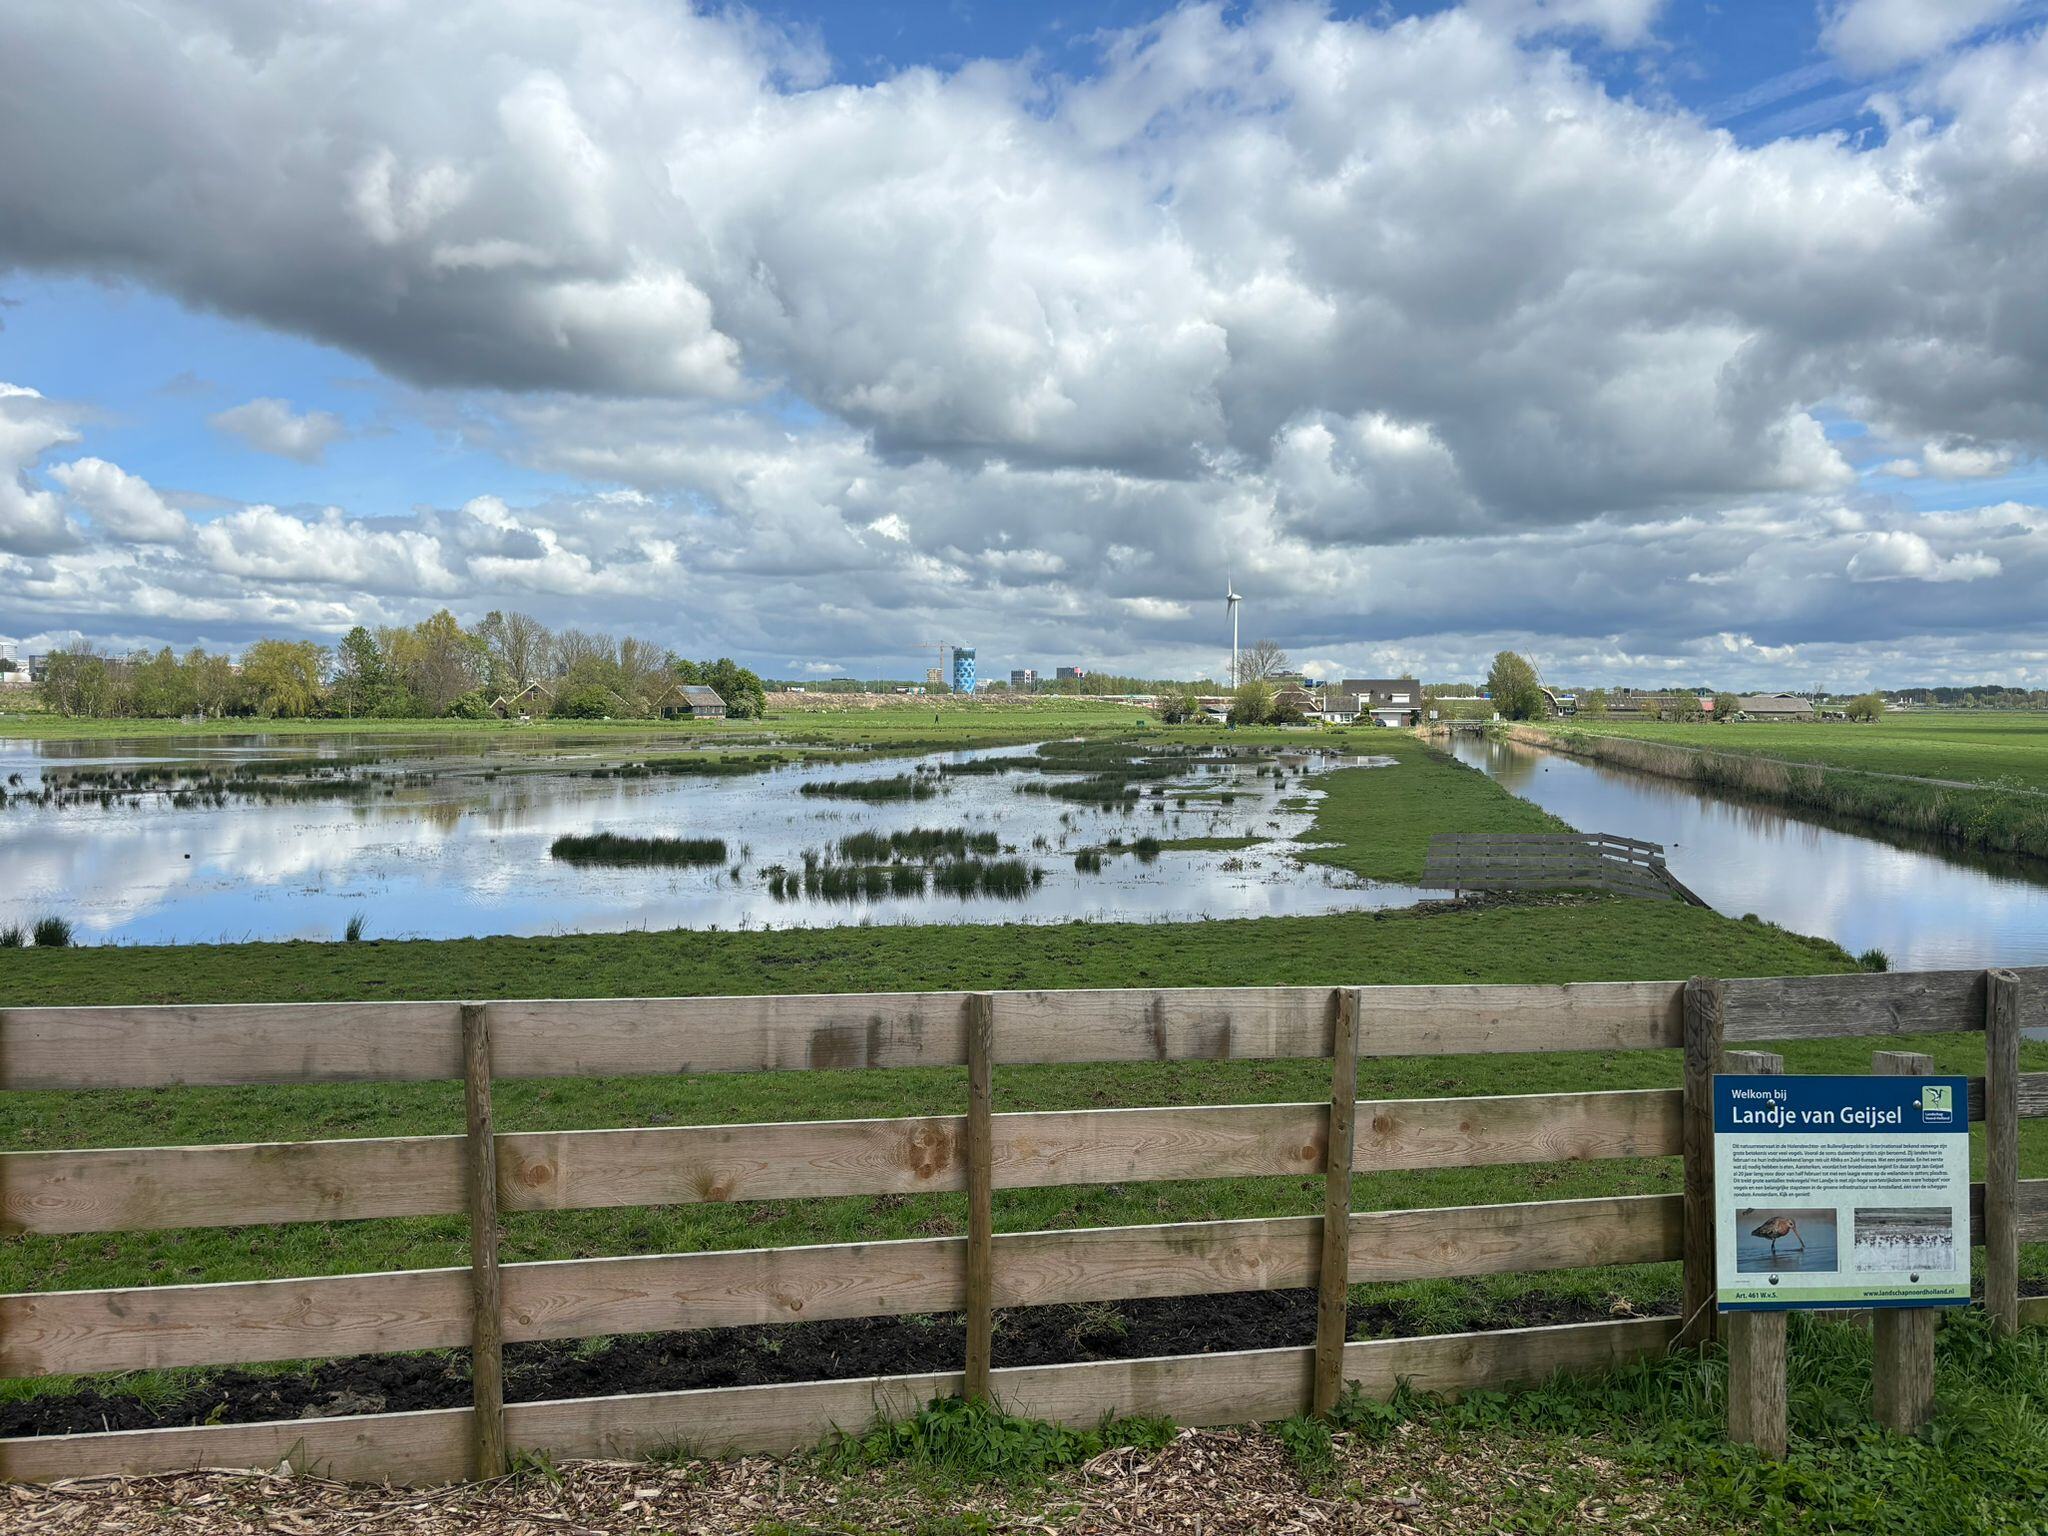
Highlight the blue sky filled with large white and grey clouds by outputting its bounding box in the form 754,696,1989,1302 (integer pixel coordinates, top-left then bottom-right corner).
0,0,2048,686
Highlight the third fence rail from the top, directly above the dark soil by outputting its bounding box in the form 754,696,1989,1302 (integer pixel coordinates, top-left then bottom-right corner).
0,1194,1679,1376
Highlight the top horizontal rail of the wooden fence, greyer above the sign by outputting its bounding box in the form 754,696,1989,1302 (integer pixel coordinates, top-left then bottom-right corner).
0,967,2048,1090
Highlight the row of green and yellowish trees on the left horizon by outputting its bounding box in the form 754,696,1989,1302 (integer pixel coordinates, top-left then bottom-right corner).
39,608,768,719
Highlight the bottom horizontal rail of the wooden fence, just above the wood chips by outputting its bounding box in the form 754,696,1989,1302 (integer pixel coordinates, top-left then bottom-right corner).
0,1319,1675,1485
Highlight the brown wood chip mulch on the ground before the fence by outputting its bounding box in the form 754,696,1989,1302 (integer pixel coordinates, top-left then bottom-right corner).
0,1425,1690,1536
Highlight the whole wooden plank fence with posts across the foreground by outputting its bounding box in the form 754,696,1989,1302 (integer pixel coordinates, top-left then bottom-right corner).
0,969,2048,1483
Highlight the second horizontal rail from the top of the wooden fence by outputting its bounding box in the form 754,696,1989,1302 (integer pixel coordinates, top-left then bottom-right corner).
0,1097,1695,1233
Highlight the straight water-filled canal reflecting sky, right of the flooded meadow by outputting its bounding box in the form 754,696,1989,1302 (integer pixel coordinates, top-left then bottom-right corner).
1452,735,2048,969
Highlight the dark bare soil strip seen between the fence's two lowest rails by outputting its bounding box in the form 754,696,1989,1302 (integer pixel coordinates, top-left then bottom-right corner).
0,1290,1654,1436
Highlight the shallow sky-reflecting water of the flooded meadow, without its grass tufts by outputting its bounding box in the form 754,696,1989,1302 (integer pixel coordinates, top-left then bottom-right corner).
0,733,1419,944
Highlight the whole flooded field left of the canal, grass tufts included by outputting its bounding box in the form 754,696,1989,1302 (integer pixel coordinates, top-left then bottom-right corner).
0,735,1421,944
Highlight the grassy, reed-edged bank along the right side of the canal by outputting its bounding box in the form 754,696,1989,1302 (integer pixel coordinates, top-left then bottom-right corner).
1509,725,2048,858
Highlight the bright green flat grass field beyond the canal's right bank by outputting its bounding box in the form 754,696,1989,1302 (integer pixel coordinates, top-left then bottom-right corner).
1571,711,2048,793
